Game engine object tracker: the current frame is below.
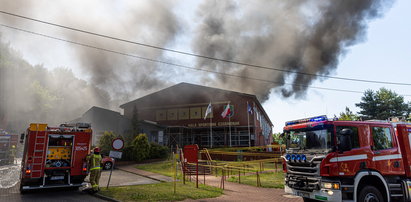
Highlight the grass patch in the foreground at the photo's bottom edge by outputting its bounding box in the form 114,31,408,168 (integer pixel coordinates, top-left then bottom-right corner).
100,182,223,201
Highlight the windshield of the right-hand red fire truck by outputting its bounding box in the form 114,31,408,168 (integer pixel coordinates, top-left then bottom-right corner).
286,128,334,151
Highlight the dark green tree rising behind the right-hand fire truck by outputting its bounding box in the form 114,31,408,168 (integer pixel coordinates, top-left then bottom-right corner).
355,88,411,120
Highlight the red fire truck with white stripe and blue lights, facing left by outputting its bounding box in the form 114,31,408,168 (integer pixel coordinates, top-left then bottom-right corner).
283,116,411,202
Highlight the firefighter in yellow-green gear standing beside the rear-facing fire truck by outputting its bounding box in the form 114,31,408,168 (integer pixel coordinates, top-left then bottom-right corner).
88,147,102,192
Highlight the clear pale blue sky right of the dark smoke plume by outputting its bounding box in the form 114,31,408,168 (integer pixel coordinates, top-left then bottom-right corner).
263,0,411,132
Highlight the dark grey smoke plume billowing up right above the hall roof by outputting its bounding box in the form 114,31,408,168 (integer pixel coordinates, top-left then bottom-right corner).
192,0,391,101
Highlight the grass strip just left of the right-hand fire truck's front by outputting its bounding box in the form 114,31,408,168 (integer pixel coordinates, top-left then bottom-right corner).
228,172,284,189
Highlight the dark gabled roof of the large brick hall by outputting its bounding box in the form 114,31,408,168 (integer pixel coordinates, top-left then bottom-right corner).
120,82,273,126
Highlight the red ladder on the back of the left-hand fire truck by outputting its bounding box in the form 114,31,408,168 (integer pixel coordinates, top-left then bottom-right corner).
30,124,47,181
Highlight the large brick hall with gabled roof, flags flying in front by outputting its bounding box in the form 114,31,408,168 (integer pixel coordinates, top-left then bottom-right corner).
120,83,273,147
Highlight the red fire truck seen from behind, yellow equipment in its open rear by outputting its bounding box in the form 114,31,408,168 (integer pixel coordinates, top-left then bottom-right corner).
20,123,92,192
